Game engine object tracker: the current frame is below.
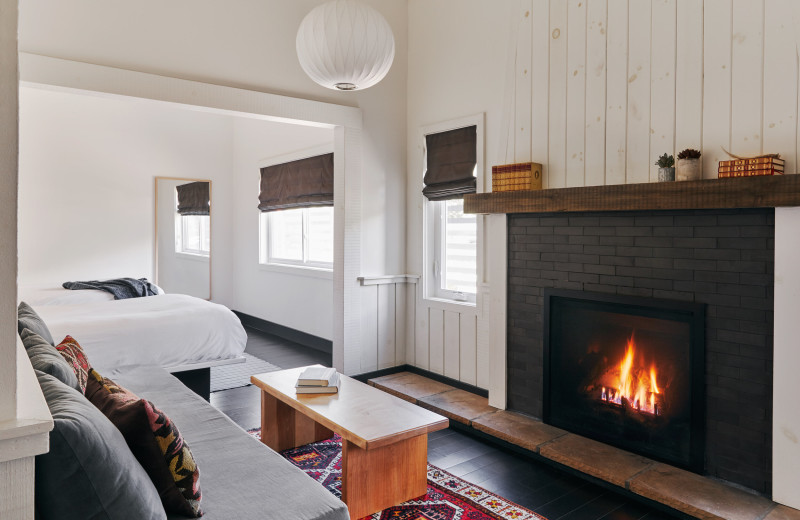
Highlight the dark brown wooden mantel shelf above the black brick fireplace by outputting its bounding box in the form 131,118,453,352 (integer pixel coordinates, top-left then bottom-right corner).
464,175,800,214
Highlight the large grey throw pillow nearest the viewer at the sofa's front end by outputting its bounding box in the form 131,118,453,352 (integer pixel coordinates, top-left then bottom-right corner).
35,371,167,520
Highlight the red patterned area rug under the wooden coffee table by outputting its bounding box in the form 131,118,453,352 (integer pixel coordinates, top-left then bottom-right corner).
249,428,547,520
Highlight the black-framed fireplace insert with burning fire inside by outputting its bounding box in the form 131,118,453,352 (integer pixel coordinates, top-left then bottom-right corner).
543,289,705,472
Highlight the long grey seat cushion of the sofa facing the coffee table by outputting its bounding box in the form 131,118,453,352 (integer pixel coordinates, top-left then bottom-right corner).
109,367,350,520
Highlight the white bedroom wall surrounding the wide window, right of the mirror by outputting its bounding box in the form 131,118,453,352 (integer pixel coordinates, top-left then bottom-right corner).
231,119,333,339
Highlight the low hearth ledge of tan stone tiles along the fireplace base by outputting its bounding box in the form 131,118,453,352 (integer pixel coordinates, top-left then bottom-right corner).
369,372,800,520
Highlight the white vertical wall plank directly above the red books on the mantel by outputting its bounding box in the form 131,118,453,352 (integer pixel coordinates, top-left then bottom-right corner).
729,0,764,155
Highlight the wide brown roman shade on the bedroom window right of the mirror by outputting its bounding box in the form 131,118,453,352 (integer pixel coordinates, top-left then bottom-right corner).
258,153,333,211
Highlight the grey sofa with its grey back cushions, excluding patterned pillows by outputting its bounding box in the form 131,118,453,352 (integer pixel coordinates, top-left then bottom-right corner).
19,303,350,520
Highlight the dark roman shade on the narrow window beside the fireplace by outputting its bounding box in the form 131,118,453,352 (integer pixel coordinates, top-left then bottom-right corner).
422,126,478,200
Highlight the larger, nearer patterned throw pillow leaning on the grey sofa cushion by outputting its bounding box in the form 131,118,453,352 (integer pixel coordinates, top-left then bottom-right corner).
86,369,203,518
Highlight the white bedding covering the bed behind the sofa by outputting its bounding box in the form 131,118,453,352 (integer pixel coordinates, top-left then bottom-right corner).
34,290,247,375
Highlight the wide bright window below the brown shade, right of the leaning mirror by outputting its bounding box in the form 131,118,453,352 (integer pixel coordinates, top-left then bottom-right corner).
261,206,333,269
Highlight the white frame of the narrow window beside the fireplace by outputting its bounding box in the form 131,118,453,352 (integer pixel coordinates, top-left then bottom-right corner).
418,112,485,307
